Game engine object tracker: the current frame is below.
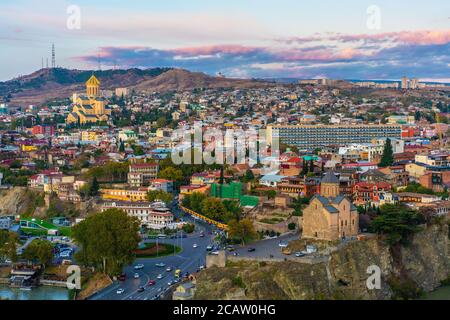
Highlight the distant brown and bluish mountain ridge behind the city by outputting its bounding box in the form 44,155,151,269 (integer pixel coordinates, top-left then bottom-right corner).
0,68,271,105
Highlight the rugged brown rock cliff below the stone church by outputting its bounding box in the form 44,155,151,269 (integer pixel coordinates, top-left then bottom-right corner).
195,224,450,300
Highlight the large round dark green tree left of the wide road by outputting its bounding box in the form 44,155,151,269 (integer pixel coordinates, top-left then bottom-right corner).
72,209,140,275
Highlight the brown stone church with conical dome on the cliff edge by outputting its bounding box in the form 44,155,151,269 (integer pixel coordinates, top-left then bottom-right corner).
302,172,359,241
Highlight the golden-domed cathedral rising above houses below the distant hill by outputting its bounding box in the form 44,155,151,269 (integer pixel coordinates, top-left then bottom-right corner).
66,75,111,124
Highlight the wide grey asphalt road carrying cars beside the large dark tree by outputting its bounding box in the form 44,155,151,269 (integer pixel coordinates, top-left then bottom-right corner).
90,204,219,300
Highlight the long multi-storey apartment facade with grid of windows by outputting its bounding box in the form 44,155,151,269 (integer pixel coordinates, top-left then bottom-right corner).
266,124,402,149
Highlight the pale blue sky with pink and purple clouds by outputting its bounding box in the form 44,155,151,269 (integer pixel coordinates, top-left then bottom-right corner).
0,0,450,82
